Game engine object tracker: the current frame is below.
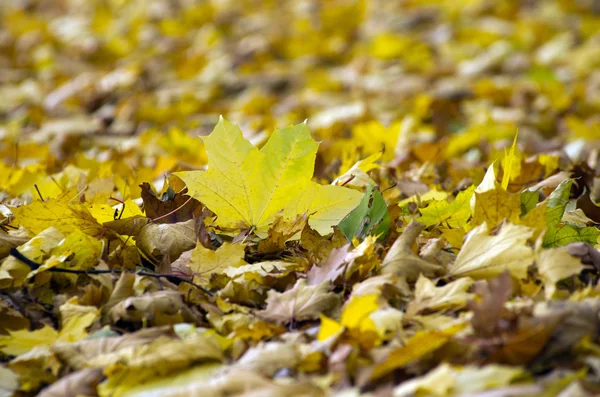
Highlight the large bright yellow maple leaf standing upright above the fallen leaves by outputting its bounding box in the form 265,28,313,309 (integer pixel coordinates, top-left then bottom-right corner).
175,118,362,237
